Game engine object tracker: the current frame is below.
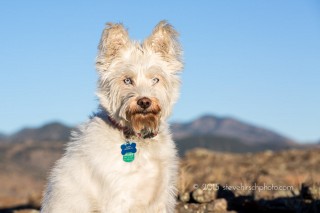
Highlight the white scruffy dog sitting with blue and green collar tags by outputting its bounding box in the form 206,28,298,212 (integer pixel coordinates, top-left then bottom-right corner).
41,21,183,213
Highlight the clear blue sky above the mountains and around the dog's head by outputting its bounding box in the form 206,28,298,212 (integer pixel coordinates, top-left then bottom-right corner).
0,0,320,141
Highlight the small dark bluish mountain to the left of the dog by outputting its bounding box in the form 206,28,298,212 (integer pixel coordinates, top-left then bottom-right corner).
6,122,72,142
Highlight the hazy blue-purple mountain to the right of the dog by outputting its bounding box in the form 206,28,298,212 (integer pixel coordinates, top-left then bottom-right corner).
171,115,294,145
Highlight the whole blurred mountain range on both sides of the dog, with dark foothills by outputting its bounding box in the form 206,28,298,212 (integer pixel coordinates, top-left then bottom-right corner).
0,115,299,155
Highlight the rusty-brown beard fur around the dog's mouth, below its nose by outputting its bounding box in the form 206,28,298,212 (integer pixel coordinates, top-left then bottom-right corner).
126,100,161,138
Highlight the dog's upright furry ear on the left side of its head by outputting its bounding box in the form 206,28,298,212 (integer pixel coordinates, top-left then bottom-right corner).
96,23,129,72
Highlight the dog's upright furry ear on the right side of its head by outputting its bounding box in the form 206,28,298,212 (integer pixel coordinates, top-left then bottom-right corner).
144,21,182,70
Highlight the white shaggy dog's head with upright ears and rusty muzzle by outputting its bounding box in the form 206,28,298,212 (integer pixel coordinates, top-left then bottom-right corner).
96,21,183,137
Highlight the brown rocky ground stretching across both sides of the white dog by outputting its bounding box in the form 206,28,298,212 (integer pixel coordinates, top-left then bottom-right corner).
0,146,320,213
